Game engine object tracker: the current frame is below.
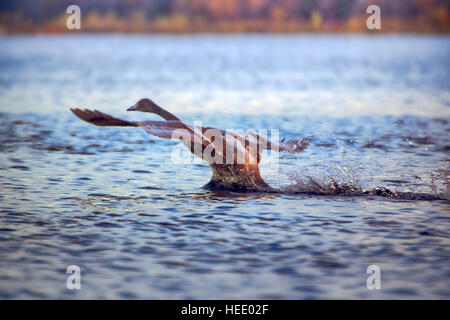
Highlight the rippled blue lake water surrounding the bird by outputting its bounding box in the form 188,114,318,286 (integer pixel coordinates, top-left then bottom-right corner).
0,35,450,299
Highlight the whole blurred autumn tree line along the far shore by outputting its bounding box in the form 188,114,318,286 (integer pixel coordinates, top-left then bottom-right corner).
0,0,450,33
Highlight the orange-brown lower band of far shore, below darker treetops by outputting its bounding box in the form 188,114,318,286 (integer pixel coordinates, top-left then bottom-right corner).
0,16,450,34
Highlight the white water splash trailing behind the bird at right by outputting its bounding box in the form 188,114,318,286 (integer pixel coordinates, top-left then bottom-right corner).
277,133,450,200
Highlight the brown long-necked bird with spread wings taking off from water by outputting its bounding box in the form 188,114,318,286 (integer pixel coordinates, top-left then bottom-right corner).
70,99,308,192
